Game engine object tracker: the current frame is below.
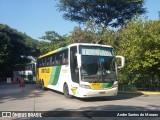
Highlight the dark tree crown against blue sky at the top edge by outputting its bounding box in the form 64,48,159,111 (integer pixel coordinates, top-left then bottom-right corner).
58,0,145,28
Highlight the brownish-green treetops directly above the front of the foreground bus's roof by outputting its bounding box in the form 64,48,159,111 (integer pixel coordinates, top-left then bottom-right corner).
69,21,118,49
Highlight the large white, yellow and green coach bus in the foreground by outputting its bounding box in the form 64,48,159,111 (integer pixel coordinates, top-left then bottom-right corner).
36,43,125,98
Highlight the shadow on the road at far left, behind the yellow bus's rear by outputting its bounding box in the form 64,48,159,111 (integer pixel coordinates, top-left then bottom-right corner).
0,84,43,103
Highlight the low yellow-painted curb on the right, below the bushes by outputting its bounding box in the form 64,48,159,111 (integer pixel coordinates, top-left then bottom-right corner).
118,91,160,95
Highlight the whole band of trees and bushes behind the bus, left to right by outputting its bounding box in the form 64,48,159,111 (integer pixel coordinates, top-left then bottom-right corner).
0,17,160,88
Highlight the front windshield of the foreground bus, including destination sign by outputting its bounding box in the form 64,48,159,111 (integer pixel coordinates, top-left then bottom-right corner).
80,46,117,83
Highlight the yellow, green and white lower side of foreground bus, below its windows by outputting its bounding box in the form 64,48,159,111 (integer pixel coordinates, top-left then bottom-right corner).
37,65,78,95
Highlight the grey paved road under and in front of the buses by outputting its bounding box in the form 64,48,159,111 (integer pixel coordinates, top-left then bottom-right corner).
0,84,160,120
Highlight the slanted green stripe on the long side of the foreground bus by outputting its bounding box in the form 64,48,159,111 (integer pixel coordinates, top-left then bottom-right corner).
49,66,61,85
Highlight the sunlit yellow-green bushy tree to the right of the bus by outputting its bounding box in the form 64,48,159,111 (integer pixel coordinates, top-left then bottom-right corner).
117,19,160,84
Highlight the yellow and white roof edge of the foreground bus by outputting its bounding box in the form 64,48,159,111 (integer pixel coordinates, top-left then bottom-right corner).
38,43,112,58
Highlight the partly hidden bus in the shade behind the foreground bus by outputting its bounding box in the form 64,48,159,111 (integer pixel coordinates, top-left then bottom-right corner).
13,62,36,83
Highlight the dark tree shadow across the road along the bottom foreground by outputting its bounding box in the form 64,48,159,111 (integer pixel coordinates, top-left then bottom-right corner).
36,105,160,120
